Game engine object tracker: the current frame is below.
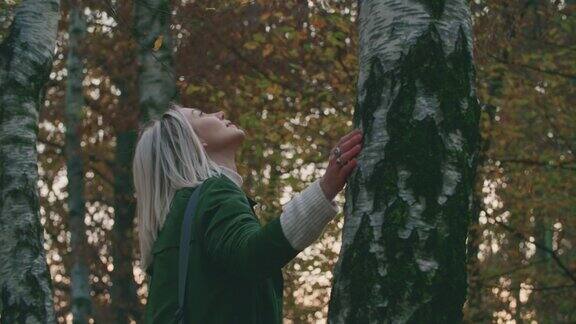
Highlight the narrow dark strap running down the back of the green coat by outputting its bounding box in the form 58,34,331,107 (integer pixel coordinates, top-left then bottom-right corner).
174,182,204,324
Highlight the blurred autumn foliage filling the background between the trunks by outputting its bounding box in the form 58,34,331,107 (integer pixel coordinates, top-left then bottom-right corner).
0,0,576,323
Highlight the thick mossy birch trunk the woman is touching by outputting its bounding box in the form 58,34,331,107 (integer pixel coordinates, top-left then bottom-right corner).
329,0,480,323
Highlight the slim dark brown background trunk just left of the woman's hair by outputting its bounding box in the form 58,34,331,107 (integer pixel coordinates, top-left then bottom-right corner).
110,1,142,323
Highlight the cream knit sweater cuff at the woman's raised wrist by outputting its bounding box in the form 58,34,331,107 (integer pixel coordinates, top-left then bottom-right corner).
280,178,340,251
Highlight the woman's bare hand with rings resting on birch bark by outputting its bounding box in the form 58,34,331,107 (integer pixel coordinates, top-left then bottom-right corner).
320,129,362,201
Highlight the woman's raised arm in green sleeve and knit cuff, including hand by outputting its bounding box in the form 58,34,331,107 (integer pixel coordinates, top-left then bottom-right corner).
201,132,360,279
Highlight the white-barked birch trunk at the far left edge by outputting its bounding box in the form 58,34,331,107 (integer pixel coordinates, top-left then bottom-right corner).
0,0,60,323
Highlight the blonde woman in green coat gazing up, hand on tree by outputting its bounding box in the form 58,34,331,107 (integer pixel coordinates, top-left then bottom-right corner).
133,104,361,324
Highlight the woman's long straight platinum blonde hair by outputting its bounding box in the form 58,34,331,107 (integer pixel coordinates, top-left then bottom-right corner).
132,103,221,270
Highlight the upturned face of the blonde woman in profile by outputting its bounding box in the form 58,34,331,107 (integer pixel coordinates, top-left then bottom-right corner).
182,108,246,153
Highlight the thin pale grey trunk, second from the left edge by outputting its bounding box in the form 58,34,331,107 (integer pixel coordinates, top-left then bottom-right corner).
66,1,92,323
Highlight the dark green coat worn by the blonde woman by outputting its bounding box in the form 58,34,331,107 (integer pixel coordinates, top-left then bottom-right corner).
145,175,300,324
